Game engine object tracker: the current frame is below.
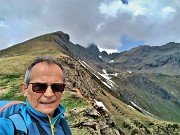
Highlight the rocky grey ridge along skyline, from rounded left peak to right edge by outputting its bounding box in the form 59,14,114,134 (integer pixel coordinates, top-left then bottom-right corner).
1,31,180,75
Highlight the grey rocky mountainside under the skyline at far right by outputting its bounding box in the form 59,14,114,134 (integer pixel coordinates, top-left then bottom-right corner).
109,42,180,75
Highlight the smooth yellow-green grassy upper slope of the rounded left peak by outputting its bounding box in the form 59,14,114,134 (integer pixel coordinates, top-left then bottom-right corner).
0,31,69,57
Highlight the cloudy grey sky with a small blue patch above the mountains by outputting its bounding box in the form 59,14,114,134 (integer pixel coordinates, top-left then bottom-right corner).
0,0,180,53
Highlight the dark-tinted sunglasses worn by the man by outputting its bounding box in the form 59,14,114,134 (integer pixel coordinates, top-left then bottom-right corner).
29,83,66,93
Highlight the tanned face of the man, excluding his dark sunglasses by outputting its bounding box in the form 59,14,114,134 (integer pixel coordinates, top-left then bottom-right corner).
23,62,64,116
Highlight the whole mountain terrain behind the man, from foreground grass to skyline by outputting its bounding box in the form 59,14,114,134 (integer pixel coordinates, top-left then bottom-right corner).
0,32,180,135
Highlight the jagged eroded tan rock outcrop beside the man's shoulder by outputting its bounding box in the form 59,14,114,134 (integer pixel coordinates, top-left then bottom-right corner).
70,106,123,135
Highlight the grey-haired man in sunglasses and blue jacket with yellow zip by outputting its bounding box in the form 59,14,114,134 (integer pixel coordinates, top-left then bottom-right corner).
0,56,71,135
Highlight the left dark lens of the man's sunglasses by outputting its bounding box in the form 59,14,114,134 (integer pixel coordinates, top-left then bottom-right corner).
32,83,47,93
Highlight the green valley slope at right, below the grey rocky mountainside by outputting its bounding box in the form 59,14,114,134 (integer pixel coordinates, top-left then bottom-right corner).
110,73,180,122
